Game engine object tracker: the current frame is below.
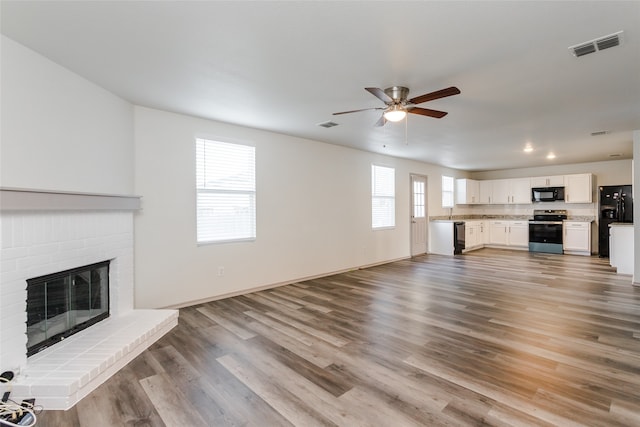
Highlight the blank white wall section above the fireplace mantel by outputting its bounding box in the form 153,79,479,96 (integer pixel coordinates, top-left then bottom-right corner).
0,36,133,194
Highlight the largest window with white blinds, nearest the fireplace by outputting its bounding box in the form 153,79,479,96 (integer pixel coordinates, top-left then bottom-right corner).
196,139,256,243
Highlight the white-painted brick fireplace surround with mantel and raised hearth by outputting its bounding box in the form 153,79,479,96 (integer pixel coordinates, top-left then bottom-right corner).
0,189,178,409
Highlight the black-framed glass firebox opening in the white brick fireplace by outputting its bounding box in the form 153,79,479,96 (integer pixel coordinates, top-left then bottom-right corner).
27,261,109,356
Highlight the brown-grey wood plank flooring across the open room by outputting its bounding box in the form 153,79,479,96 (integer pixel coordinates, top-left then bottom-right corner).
33,249,640,427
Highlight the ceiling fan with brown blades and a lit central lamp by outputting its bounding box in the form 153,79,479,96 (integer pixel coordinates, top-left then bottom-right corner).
333,86,460,126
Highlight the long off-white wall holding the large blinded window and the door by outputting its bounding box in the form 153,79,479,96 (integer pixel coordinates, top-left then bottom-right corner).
135,107,460,308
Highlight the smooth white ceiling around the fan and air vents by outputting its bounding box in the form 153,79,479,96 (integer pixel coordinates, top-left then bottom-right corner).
1,0,640,171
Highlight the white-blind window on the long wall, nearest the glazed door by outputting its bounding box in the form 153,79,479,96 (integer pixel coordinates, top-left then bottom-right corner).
371,165,396,229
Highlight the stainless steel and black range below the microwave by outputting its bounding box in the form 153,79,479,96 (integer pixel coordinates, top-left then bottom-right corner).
529,209,567,254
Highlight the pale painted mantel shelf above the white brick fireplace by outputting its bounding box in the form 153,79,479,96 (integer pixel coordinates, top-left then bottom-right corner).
0,187,141,211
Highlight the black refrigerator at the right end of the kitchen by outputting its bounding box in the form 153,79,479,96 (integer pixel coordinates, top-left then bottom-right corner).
598,185,633,258
